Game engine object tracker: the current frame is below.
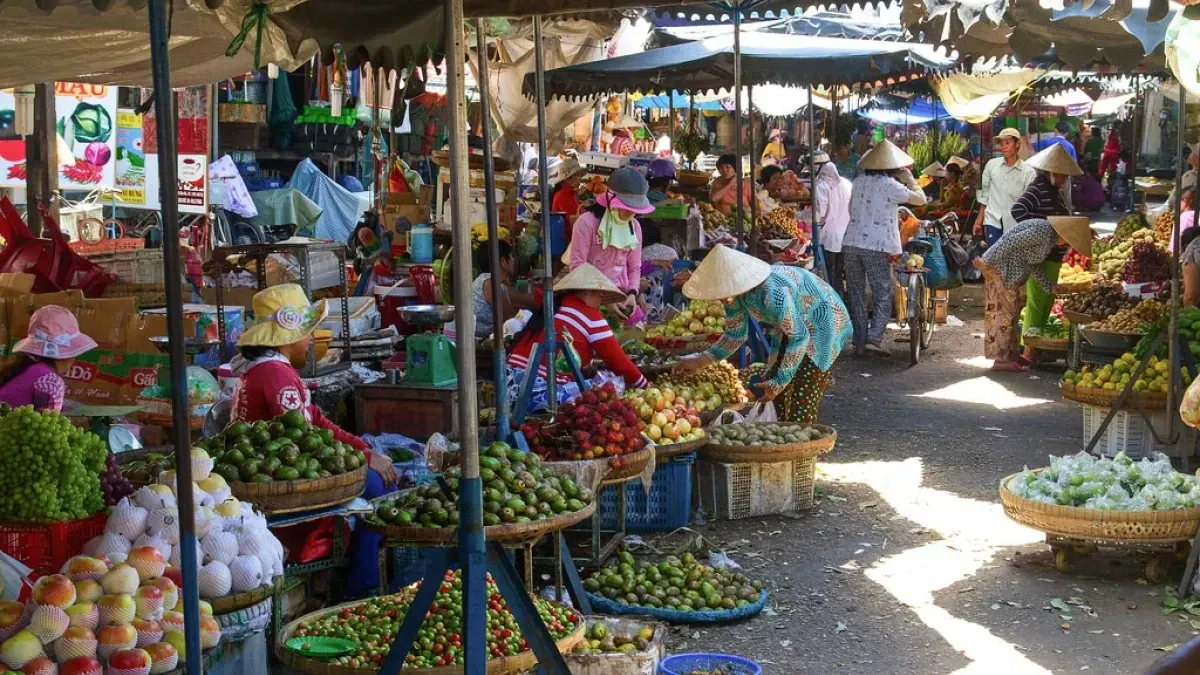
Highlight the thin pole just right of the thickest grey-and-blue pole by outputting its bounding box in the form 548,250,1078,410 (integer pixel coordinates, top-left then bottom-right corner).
475,19,509,441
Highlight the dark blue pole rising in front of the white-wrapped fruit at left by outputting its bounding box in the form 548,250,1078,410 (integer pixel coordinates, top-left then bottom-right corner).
148,0,203,673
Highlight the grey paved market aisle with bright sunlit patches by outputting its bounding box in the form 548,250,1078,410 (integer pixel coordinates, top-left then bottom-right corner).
657,287,1200,675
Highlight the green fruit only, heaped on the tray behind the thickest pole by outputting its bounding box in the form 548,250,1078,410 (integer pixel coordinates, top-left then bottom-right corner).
368,443,592,527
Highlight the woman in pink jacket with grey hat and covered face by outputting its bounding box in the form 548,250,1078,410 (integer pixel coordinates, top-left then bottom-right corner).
569,168,654,319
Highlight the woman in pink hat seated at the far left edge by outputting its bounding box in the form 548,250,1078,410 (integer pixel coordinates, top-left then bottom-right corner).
0,305,96,412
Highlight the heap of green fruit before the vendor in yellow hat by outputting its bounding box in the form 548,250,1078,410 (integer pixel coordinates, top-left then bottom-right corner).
196,411,367,483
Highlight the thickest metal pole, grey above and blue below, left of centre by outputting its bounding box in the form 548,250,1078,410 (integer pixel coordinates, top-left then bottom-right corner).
441,0,487,673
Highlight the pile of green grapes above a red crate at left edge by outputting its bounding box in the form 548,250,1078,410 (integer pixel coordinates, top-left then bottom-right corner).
0,405,108,521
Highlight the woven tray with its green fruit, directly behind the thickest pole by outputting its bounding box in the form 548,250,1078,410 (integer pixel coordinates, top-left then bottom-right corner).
364,443,596,544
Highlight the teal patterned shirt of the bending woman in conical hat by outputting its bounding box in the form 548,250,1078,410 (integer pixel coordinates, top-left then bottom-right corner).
708,265,852,392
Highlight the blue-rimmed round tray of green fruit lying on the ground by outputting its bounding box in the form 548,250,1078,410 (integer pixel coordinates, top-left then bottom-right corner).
583,551,767,623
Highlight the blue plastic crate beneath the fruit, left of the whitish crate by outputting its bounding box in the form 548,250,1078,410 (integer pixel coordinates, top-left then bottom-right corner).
596,453,696,532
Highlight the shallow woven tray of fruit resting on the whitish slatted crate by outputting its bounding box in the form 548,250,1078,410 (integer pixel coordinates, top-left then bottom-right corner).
700,422,838,464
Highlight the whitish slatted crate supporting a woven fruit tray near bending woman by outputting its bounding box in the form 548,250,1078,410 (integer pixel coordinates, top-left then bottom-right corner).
692,458,816,520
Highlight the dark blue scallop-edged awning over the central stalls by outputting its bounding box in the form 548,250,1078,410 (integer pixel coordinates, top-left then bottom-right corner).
524,32,955,97
